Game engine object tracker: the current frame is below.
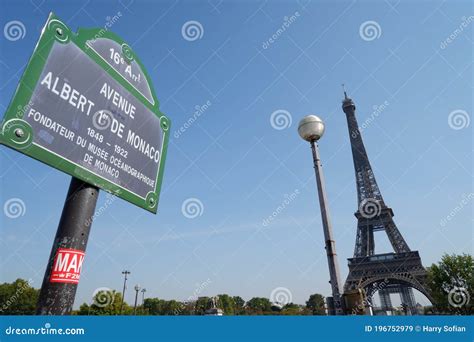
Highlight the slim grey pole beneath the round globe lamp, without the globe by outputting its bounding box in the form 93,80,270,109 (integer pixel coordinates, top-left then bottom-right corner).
311,140,344,315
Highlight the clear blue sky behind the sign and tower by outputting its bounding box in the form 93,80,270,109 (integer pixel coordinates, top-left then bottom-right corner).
0,0,474,307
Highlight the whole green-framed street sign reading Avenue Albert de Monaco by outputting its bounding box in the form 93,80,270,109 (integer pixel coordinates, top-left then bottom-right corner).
0,13,170,213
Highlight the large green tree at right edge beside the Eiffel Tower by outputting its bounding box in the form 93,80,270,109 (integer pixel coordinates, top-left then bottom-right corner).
428,254,474,315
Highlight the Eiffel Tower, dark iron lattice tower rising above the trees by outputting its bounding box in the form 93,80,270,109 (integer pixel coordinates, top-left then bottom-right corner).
342,90,433,314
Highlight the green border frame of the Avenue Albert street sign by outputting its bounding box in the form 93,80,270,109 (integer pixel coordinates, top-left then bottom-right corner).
0,13,171,214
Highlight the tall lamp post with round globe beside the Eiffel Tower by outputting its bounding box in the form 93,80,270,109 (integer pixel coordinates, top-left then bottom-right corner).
298,115,344,315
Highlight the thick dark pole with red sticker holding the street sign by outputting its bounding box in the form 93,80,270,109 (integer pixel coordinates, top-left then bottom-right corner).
36,177,99,315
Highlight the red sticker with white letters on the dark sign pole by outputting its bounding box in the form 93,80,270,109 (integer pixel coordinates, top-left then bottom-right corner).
49,248,85,284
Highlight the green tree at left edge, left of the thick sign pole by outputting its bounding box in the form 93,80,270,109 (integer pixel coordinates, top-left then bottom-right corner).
0,279,39,315
